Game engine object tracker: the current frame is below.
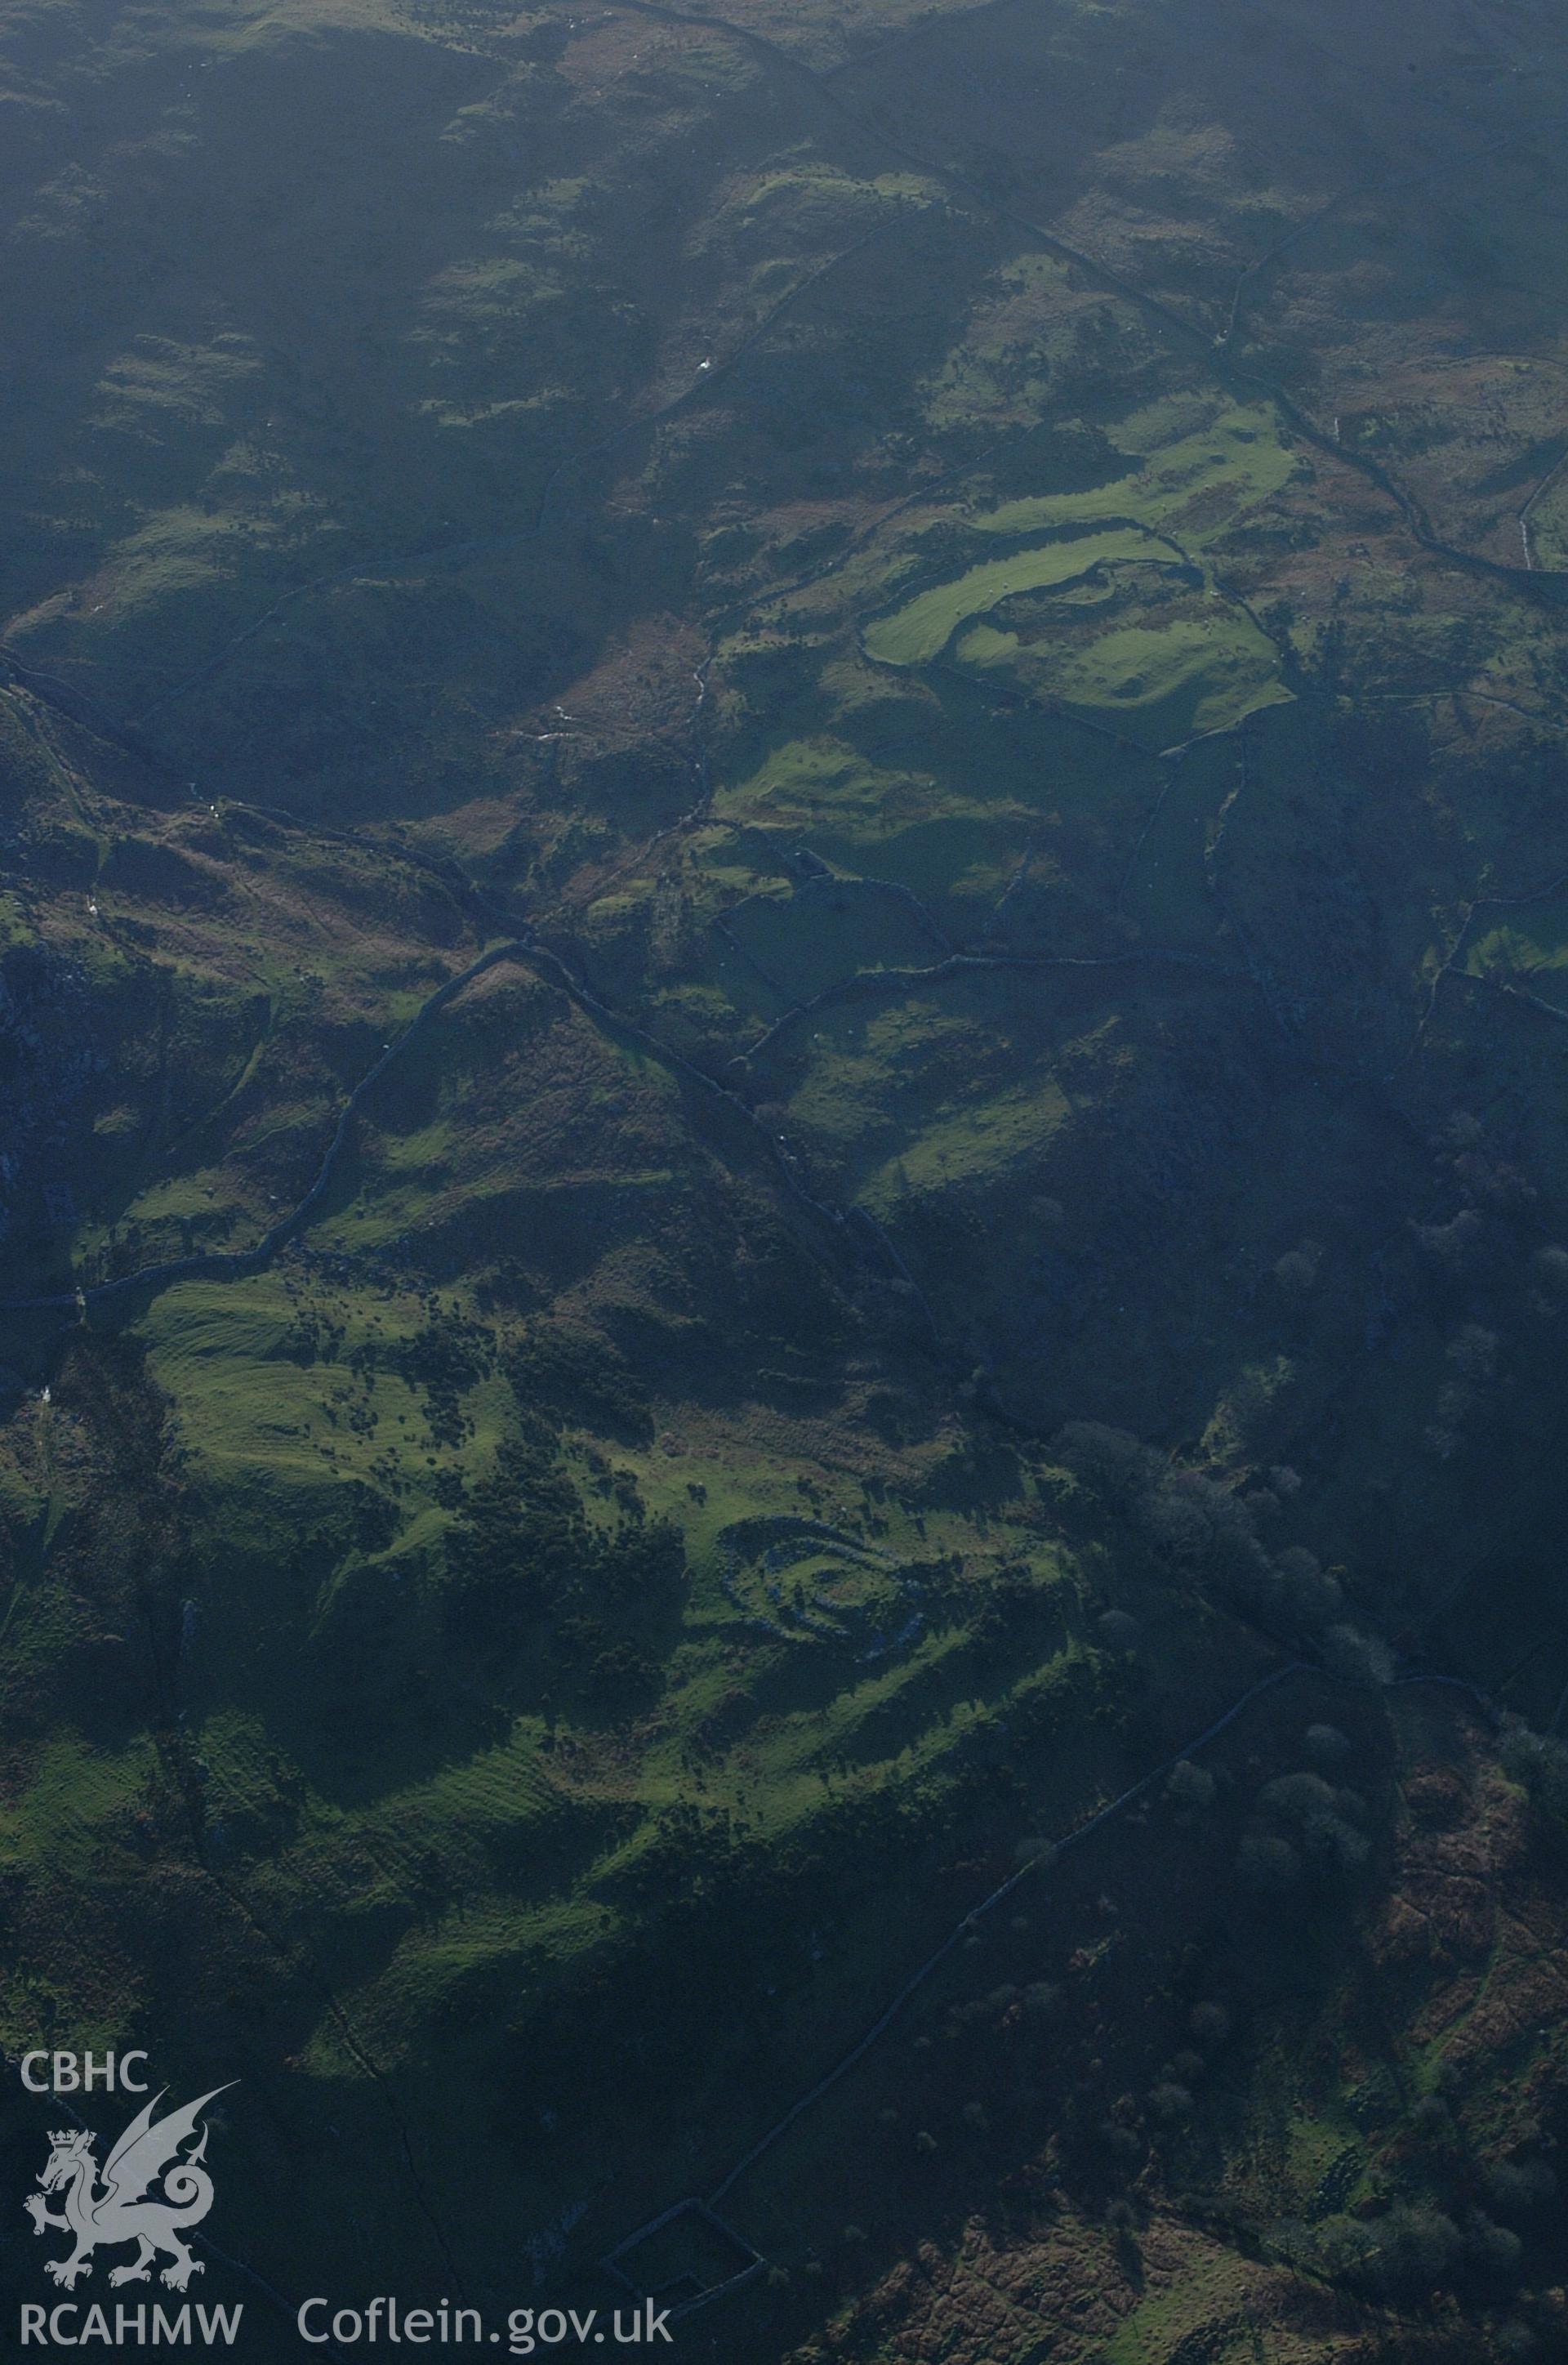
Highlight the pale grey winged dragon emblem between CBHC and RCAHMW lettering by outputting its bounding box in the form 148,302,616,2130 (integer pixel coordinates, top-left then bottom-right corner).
21,2086,229,2291
